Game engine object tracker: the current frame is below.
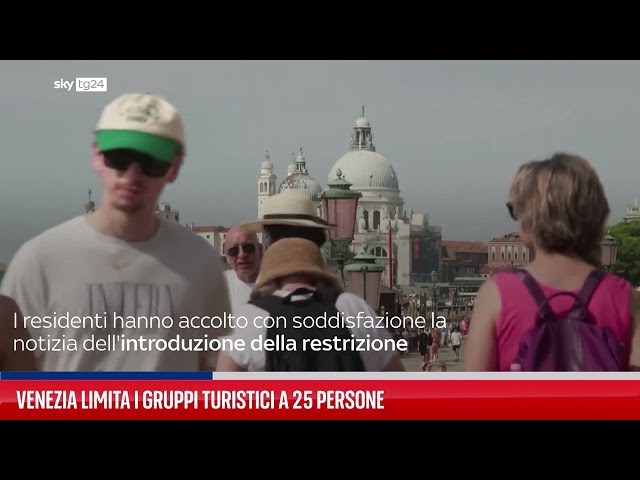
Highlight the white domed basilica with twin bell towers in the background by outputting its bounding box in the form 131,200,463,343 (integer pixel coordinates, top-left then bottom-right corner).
258,106,442,287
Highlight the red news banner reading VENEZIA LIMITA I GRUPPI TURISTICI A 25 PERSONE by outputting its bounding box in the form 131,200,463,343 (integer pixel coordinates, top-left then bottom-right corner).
0,377,640,420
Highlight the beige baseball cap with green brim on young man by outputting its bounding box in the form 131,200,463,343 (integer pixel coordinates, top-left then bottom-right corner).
95,93,185,162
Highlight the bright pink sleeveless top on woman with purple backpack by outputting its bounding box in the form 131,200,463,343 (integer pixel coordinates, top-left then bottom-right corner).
493,272,631,371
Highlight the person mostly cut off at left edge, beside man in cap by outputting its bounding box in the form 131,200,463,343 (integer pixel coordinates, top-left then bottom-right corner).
0,295,37,372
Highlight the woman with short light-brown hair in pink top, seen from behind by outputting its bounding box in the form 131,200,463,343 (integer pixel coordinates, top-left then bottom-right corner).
464,153,640,371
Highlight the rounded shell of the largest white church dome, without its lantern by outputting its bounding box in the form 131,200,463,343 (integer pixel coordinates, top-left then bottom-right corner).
328,150,400,190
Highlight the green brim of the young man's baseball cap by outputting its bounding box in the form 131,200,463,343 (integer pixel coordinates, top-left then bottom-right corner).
96,130,182,163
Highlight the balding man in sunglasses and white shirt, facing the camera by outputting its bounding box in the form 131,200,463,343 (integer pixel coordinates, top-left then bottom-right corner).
224,225,262,313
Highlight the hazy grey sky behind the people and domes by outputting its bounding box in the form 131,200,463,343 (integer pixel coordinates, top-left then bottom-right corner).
0,61,640,263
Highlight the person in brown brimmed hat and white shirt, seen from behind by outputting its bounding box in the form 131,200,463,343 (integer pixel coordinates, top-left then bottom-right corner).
217,238,404,372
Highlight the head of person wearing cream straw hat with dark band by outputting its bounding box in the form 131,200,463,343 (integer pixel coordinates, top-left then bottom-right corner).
242,190,335,247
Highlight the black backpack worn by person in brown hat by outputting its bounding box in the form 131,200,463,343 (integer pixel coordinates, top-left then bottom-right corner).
249,288,365,372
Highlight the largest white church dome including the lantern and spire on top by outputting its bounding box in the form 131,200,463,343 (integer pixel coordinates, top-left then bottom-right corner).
328,105,400,191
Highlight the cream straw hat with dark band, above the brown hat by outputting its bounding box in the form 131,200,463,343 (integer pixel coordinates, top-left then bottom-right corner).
242,190,335,231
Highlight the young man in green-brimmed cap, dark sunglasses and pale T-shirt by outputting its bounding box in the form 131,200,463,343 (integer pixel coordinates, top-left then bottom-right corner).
0,93,230,371
